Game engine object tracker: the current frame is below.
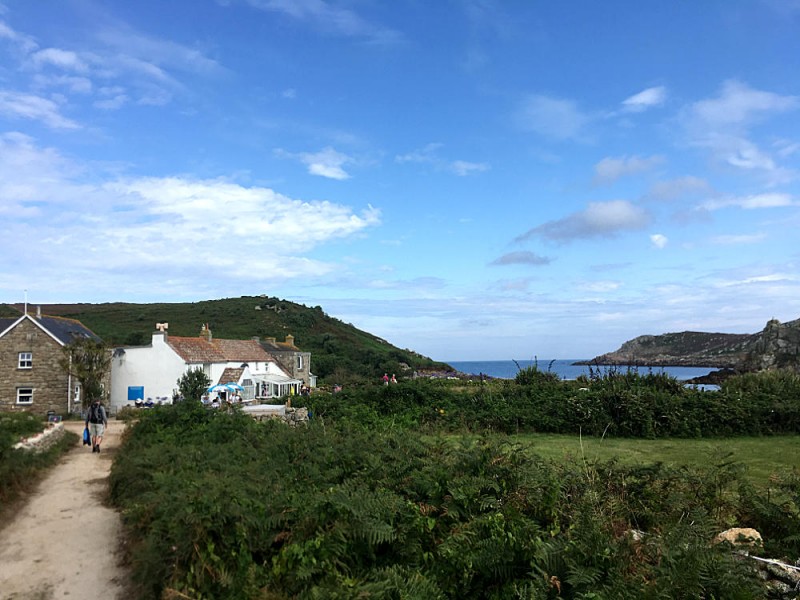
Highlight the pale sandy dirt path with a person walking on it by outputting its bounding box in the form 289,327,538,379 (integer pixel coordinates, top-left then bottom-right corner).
0,421,127,600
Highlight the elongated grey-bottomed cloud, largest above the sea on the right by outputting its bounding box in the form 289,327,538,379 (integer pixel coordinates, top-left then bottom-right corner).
517,200,650,242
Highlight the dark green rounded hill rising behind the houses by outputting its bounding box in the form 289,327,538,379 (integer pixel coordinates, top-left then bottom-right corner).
7,296,446,383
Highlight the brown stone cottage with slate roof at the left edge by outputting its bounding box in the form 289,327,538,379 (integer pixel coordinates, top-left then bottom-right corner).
0,311,99,416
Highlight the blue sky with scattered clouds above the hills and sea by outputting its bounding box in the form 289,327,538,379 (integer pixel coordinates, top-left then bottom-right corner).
0,0,800,360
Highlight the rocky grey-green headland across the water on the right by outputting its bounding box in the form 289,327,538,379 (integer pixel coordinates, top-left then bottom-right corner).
582,319,800,371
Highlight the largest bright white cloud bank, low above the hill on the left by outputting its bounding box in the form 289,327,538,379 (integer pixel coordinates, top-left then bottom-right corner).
0,134,380,293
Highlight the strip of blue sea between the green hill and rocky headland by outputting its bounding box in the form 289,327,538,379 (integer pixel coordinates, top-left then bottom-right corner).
447,358,716,381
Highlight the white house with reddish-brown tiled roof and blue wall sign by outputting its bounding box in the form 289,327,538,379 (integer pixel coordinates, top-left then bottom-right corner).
110,324,302,412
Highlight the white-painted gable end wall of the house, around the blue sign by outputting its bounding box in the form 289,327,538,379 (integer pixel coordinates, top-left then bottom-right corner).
110,332,189,414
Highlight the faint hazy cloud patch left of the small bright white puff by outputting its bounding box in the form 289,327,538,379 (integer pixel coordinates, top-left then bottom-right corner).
517,94,591,140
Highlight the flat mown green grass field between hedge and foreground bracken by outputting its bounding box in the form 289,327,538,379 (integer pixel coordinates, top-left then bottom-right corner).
510,434,800,486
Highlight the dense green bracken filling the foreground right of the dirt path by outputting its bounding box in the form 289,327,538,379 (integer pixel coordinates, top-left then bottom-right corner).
111,404,772,599
